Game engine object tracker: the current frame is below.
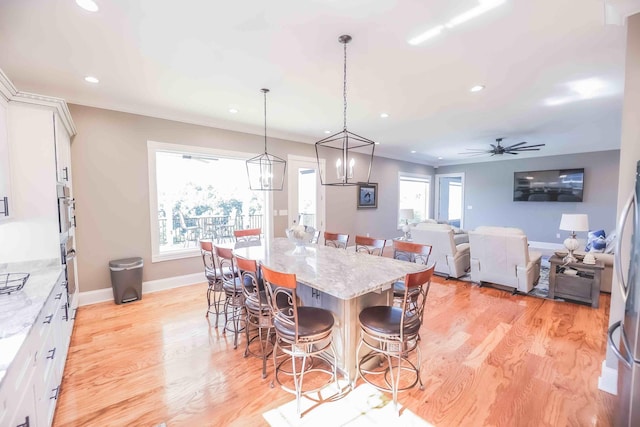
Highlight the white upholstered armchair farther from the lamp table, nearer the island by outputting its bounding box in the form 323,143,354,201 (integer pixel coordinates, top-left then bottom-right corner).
411,222,469,278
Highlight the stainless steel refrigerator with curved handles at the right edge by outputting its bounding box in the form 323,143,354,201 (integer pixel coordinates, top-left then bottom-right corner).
609,162,640,427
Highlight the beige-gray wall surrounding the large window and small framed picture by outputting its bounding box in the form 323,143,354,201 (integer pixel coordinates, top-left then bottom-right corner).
69,105,433,292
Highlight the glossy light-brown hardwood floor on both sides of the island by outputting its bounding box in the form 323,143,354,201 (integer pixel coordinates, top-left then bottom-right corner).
54,278,615,427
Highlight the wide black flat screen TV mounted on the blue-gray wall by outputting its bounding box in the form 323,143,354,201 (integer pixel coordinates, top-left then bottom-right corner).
513,169,584,202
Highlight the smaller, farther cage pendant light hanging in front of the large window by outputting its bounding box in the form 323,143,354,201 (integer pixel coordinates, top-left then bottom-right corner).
247,89,287,191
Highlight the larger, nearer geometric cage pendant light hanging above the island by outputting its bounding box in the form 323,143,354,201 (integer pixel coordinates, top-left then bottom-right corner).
315,35,375,186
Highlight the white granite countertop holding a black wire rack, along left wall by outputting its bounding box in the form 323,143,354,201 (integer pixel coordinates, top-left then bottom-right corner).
0,260,63,385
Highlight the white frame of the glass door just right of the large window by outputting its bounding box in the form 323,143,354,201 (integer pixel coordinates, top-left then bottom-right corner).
287,154,326,234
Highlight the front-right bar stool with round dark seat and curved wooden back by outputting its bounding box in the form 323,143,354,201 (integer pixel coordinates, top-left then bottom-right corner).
354,264,435,411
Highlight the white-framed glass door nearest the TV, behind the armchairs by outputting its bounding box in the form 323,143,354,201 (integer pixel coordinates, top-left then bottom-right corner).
435,173,464,228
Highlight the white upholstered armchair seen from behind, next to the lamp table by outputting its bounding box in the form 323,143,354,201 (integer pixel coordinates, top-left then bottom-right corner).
469,227,541,293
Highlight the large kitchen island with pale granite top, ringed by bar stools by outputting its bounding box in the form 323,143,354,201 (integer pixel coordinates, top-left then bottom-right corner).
234,238,426,381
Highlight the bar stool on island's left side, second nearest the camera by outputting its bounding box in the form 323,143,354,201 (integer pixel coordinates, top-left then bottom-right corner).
235,255,273,378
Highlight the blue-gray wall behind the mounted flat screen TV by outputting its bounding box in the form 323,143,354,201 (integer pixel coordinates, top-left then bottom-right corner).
436,150,620,243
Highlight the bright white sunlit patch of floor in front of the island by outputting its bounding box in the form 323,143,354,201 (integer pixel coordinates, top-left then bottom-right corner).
262,384,432,427
